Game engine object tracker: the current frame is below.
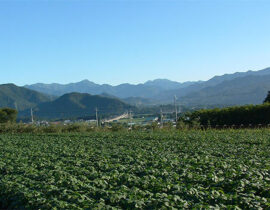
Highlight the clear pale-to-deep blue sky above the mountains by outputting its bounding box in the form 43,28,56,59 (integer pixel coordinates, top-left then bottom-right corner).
0,0,270,85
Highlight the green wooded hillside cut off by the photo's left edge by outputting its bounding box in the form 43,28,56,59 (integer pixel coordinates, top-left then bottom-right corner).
0,84,52,111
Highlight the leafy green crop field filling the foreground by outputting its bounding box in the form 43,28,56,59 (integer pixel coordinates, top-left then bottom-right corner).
0,129,270,209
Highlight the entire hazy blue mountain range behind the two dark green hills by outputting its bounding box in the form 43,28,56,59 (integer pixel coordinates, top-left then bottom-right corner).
25,68,270,105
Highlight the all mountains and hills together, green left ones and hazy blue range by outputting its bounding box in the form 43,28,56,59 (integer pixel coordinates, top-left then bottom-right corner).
0,68,270,119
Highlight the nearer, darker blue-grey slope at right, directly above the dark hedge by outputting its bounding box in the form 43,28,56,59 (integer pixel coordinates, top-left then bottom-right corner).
180,75,270,105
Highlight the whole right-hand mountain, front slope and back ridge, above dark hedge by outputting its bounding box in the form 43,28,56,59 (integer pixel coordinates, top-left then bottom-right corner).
154,68,270,106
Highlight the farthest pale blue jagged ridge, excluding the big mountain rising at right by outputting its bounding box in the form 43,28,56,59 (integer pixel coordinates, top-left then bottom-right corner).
24,79,196,98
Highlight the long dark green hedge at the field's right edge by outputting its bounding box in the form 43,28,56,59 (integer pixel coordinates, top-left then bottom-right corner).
184,103,270,126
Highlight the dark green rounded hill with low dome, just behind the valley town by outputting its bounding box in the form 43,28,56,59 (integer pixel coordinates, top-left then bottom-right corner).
22,93,132,119
